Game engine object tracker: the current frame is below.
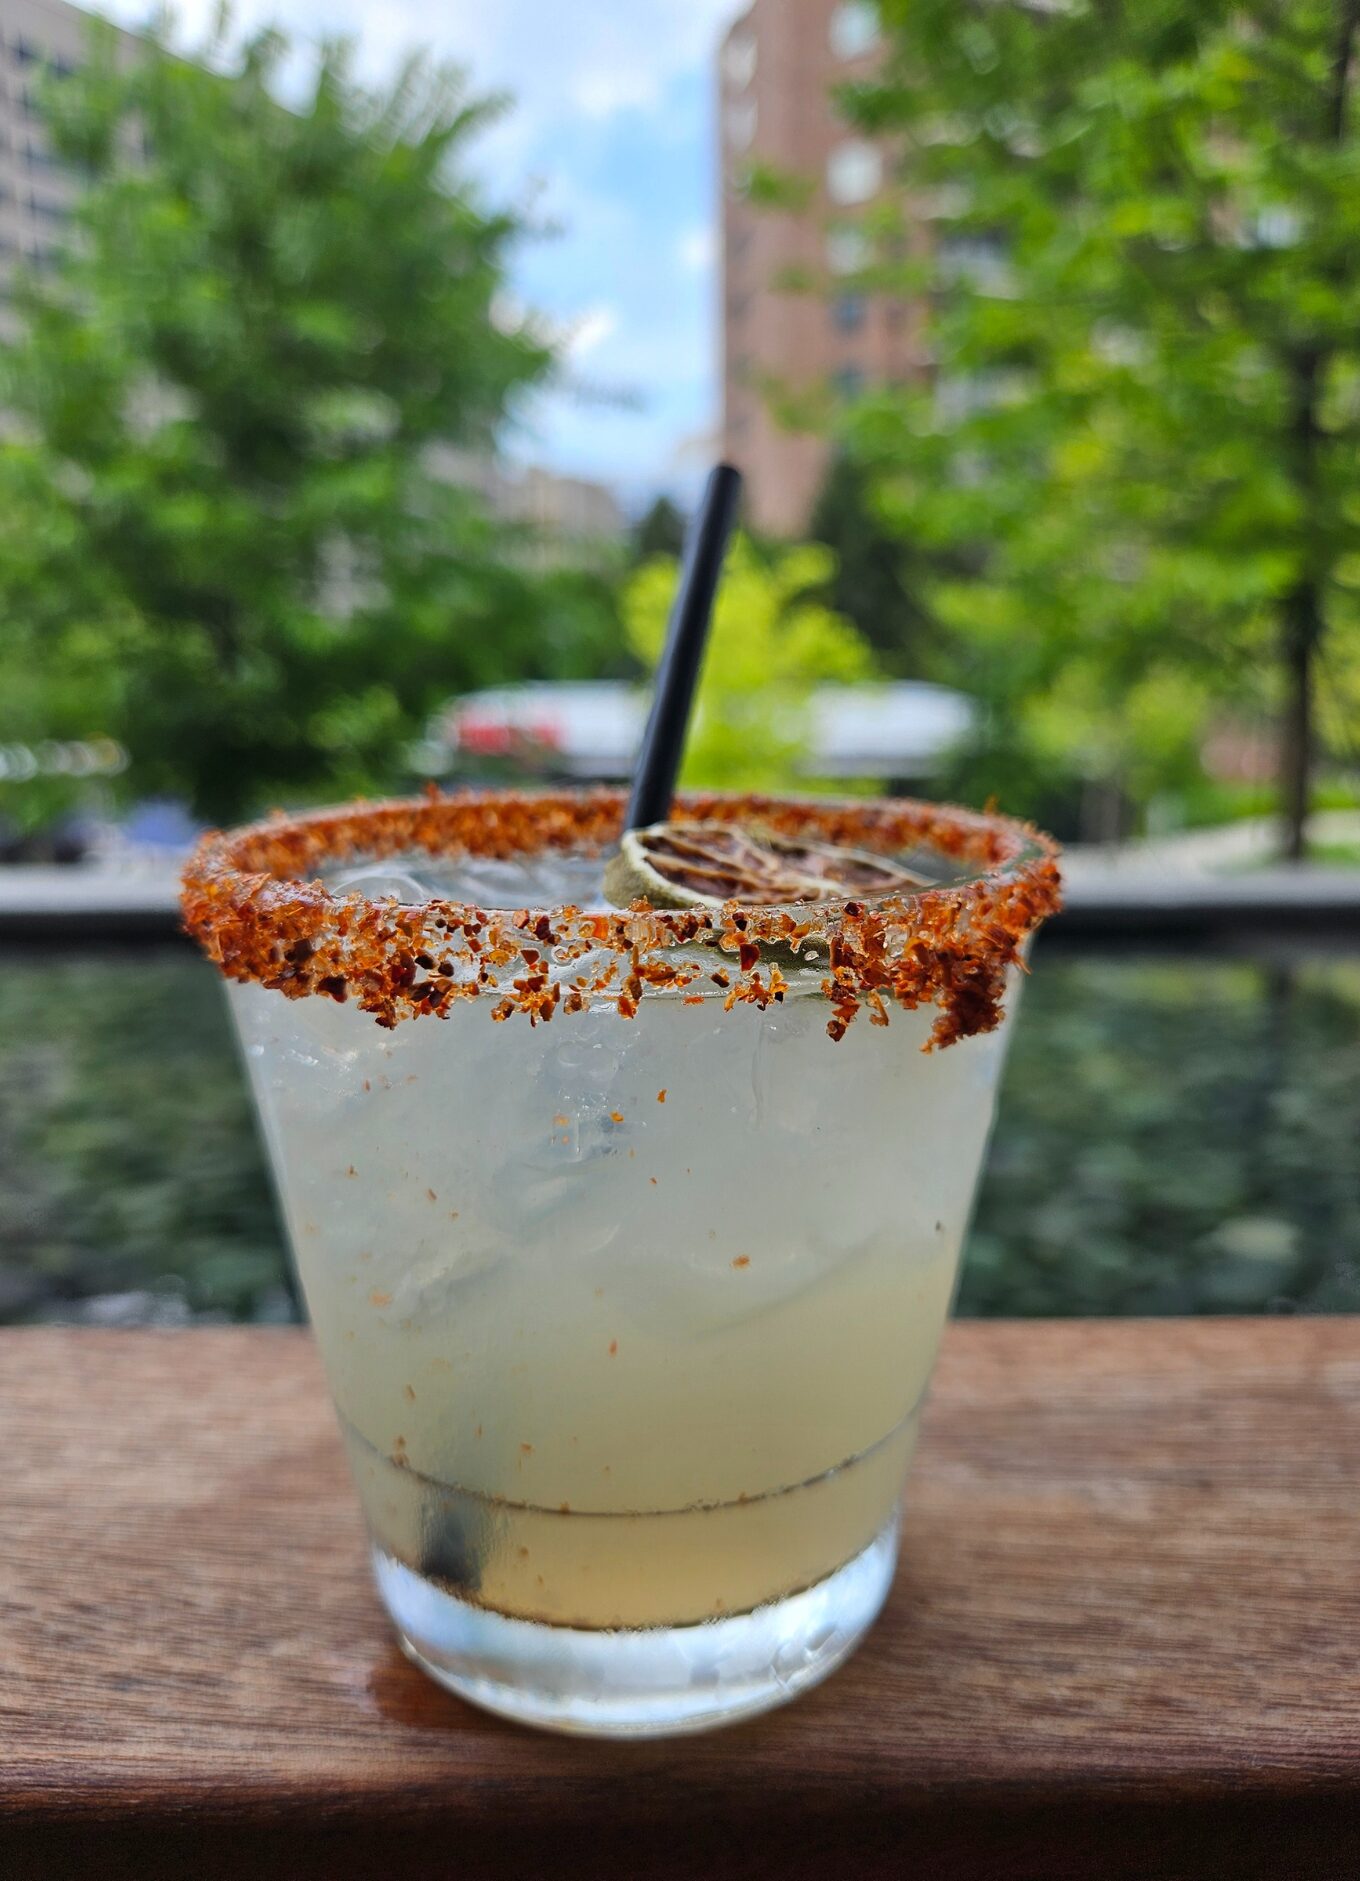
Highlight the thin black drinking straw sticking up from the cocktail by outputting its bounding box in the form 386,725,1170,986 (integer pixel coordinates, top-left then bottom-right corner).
625,465,741,830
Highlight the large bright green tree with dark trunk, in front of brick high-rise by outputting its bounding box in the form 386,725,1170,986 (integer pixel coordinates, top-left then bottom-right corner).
846,0,1360,856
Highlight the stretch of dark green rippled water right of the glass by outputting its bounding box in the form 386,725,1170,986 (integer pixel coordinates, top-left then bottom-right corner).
959,950,1360,1313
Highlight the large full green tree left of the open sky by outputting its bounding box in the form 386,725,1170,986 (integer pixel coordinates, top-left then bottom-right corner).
0,14,600,818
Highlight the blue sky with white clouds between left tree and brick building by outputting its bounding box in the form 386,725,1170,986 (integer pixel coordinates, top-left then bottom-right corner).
98,0,741,508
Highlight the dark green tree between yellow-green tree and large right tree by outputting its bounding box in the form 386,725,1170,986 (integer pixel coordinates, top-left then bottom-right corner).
807,451,929,677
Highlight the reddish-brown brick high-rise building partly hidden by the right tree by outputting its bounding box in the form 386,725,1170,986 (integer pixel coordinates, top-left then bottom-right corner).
719,0,922,534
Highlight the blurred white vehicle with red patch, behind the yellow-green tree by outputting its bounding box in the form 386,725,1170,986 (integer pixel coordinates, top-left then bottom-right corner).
430,679,976,781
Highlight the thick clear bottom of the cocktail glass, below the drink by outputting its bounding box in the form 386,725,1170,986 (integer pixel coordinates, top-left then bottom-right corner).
372,1520,897,1738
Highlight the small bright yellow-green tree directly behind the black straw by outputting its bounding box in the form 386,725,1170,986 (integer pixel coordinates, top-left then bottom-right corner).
623,536,875,790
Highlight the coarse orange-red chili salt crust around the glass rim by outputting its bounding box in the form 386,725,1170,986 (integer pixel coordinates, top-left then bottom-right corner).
181,790,1061,1046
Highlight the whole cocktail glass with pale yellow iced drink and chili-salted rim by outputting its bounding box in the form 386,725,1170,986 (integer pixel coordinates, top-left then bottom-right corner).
184,792,1057,1736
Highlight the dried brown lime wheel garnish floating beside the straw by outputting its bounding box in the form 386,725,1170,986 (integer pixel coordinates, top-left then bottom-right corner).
604,822,929,909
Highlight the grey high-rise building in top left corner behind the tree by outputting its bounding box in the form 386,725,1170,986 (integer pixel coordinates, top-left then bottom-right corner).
0,0,137,312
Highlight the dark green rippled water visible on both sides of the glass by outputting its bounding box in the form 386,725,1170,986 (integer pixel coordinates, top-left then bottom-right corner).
0,946,1360,1324
